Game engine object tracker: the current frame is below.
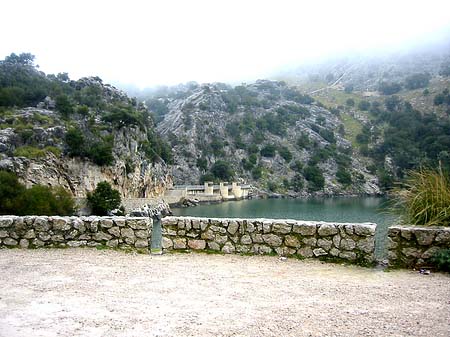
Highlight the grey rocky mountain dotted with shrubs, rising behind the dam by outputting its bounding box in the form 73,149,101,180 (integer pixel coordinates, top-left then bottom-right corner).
146,80,380,195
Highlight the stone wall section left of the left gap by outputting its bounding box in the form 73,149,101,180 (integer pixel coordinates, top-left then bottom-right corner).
0,216,153,250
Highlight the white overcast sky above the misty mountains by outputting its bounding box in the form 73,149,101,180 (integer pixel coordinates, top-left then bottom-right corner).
0,0,450,88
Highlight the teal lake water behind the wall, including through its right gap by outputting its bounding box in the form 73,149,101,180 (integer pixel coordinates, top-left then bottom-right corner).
172,197,394,258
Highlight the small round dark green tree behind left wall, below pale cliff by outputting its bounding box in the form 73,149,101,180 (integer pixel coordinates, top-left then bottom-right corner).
87,181,121,215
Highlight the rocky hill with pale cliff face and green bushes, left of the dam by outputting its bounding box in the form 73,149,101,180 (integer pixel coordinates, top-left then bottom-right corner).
0,54,172,198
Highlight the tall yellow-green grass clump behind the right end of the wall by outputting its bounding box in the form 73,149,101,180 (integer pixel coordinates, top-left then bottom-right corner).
392,169,450,226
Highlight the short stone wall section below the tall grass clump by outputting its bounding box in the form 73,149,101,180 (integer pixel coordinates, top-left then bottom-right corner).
387,226,450,268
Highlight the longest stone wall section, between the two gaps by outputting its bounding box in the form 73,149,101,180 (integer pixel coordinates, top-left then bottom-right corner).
162,217,376,263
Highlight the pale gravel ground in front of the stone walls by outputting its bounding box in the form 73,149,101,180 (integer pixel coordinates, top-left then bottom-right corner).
0,249,450,337
